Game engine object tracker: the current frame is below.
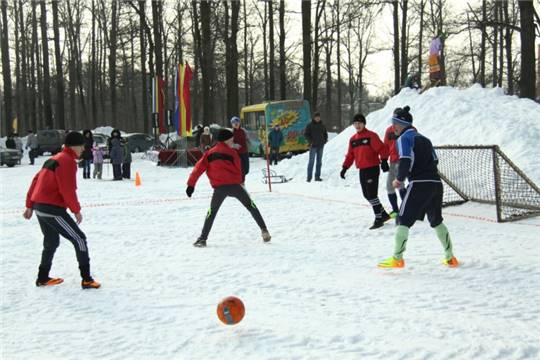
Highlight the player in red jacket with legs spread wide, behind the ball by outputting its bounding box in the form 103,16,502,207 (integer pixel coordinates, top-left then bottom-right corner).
186,129,271,247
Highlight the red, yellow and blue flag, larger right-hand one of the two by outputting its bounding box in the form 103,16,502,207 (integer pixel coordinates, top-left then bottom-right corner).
174,63,193,136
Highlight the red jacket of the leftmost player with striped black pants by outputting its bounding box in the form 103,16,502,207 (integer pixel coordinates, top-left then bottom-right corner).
26,147,81,214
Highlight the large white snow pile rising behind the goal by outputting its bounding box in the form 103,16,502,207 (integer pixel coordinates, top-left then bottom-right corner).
277,85,540,186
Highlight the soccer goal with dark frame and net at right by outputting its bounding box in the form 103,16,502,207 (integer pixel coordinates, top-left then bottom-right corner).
435,145,540,222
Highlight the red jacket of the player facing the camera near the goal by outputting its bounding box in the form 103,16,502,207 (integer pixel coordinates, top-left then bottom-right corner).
343,128,388,170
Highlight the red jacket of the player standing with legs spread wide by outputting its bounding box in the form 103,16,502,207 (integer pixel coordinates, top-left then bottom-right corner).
188,142,243,188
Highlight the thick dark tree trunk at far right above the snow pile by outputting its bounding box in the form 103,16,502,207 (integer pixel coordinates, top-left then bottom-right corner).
518,0,536,100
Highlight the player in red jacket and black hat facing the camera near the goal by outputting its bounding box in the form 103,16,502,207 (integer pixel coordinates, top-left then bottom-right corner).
340,114,390,229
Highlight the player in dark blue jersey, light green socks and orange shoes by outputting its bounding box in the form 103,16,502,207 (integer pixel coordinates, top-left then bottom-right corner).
379,106,459,268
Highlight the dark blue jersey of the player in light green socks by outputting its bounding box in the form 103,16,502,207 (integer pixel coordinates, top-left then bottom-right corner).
396,127,441,182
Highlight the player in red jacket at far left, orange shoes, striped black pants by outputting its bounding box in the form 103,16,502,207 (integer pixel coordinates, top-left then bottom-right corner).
23,131,101,289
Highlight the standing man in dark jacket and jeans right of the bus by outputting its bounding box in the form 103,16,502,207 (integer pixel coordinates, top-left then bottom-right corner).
304,112,328,182
